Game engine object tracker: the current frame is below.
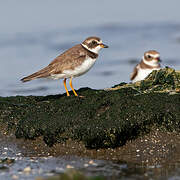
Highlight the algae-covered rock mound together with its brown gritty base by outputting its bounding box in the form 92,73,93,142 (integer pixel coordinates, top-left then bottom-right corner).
0,68,180,165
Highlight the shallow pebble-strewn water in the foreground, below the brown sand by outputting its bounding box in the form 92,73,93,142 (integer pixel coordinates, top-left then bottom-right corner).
0,140,180,180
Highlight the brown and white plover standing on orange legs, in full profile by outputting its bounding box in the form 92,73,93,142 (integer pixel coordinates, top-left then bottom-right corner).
21,37,108,96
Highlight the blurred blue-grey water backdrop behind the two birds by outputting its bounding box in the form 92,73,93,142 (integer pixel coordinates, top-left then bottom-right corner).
0,0,180,96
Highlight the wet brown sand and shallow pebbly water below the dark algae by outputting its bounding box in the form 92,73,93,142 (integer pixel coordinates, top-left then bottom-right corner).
0,130,180,179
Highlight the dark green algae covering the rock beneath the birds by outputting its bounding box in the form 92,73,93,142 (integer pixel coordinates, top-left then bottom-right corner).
0,68,180,149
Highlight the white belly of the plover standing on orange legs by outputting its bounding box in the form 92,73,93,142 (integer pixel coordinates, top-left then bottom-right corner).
51,58,96,79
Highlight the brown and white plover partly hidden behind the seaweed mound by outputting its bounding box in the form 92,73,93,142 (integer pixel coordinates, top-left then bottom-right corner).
131,50,161,83
